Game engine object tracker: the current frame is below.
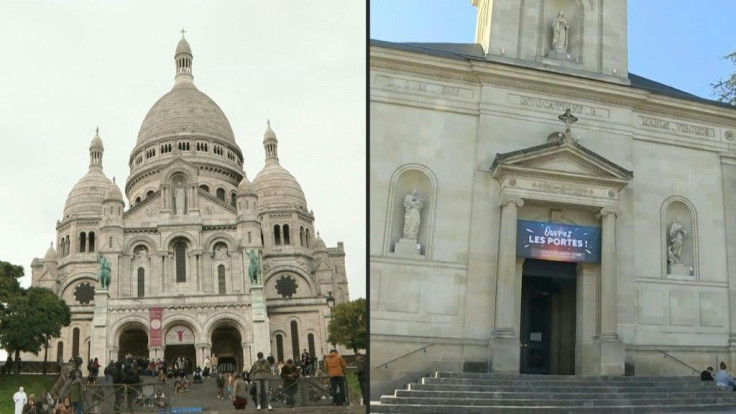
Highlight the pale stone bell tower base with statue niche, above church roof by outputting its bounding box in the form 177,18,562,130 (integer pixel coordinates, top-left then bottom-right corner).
471,0,629,84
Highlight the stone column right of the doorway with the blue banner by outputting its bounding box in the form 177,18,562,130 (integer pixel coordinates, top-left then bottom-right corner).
598,208,624,375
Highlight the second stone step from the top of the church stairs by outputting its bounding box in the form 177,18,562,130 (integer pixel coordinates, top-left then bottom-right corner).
419,377,713,389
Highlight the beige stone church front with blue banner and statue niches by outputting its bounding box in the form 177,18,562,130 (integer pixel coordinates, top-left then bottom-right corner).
369,0,736,399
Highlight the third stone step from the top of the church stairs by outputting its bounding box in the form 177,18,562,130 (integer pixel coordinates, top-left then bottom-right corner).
408,382,720,393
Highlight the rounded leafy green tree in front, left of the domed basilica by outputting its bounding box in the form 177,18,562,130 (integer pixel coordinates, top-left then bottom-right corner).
0,287,71,373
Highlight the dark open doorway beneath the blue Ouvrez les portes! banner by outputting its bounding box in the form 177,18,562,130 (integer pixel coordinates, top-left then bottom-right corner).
519,259,577,375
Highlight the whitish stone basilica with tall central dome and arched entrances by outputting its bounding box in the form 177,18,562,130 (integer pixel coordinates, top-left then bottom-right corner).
29,37,349,370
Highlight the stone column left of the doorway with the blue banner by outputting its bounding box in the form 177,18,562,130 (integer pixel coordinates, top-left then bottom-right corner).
490,197,524,372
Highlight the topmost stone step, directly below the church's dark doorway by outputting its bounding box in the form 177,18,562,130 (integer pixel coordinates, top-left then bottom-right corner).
429,371,700,382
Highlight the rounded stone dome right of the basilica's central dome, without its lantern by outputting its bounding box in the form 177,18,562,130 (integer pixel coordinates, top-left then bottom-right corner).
253,162,307,210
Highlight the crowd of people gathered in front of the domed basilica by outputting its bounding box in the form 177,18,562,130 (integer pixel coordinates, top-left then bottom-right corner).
8,349,367,414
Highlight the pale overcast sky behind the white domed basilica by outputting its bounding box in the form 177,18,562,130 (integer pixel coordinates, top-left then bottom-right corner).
0,0,366,360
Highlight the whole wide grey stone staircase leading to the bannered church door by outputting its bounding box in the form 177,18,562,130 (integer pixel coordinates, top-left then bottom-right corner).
370,372,736,414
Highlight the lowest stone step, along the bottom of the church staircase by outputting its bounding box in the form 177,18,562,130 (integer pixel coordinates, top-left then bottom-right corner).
369,403,736,414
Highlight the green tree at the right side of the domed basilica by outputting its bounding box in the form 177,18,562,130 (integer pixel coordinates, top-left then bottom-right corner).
327,298,368,353
